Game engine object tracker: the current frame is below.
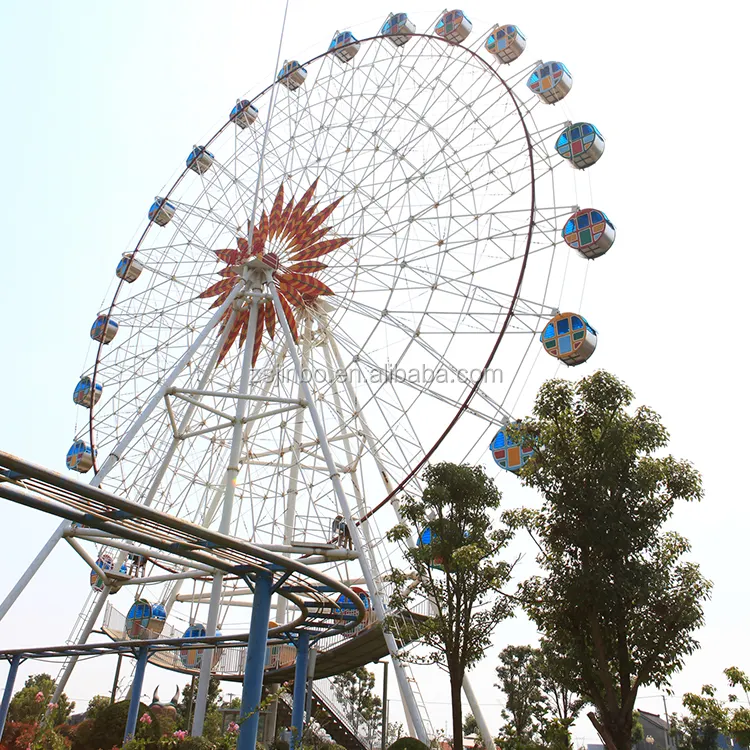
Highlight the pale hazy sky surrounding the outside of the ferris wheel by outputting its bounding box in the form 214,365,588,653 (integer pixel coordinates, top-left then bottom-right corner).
0,0,750,741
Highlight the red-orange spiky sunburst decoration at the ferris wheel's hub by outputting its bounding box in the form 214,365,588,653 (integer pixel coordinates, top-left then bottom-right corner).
198,180,351,366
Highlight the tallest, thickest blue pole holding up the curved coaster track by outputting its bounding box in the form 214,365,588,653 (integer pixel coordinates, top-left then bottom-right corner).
237,572,272,750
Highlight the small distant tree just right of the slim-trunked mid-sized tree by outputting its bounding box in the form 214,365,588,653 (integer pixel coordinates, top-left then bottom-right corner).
495,646,546,750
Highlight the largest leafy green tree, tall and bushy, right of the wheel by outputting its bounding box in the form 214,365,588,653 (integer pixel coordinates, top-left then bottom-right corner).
505,372,711,750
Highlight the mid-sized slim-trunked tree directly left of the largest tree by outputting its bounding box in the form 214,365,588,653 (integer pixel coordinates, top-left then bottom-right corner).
388,463,513,748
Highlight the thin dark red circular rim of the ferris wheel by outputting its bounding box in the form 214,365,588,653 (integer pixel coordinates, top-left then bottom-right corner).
88,33,537,525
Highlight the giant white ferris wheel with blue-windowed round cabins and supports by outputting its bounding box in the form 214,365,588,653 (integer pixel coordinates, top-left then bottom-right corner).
51,10,615,748
